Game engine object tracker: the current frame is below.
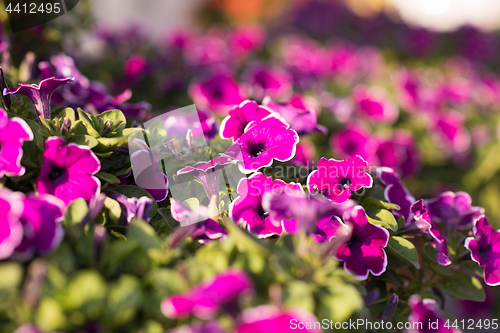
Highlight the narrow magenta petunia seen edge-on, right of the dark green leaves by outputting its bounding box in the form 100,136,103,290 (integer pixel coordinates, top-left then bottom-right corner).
410,199,451,266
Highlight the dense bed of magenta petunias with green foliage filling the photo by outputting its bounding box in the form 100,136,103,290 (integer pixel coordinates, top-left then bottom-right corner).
0,0,500,333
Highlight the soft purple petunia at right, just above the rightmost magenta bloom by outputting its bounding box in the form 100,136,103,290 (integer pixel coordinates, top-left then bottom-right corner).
425,191,484,229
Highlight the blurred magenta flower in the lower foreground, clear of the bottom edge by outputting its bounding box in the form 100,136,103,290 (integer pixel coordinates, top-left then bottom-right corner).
161,269,253,319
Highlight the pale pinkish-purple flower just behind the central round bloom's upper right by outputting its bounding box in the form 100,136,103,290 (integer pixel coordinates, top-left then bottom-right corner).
262,98,327,135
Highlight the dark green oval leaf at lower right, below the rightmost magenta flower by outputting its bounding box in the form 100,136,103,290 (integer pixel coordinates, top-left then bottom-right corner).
436,273,486,302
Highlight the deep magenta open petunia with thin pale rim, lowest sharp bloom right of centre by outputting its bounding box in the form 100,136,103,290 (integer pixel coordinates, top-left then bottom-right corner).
332,206,389,280
